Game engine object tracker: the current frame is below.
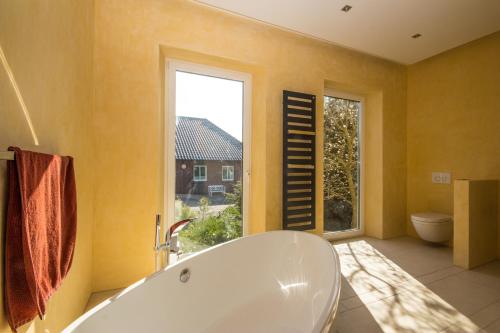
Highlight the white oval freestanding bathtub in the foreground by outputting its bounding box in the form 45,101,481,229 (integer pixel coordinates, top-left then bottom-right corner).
63,231,340,333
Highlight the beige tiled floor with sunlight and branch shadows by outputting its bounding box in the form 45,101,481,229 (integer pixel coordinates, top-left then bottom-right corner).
331,237,500,333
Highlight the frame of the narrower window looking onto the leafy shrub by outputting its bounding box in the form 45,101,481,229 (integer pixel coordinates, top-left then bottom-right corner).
321,88,365,240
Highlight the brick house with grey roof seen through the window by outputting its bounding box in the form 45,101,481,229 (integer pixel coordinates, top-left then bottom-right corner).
175,117,243,195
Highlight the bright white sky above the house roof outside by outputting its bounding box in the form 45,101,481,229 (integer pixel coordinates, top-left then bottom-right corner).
175,71,243,141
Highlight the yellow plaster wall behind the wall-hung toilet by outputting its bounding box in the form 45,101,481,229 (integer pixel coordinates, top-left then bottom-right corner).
406,32,500,255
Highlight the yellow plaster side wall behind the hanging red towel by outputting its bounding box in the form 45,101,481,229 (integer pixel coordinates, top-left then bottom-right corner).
0,0,95,333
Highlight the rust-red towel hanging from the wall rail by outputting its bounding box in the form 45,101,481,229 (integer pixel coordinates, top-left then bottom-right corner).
4,147,76,331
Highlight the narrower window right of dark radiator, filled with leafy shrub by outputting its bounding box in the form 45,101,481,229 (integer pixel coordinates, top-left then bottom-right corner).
323,93,362,237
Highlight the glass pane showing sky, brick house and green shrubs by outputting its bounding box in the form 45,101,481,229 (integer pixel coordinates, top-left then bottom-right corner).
173,71,244,262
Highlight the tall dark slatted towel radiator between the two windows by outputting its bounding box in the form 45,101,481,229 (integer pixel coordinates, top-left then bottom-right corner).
283,90,316,230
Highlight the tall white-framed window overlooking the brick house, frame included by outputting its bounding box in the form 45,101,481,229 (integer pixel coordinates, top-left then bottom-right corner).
164,60,251,262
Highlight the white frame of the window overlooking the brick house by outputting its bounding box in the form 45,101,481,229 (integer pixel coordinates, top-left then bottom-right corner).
163,59,252,236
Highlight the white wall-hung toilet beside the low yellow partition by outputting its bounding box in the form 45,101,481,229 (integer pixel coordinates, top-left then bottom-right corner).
411,213,453,243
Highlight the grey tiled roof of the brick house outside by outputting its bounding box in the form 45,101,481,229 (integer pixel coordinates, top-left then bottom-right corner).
175,117,243,161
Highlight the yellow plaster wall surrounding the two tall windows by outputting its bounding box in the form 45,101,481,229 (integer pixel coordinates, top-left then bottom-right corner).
93,0,406,290
